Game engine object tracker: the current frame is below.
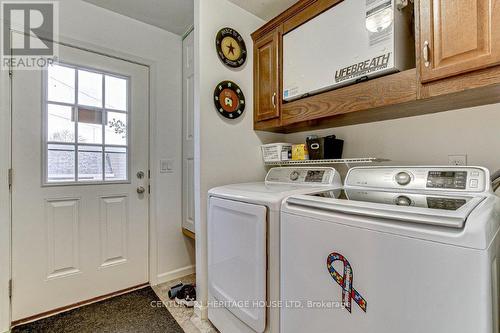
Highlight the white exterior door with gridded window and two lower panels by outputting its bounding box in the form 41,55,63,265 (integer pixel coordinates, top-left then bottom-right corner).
12,45,149,321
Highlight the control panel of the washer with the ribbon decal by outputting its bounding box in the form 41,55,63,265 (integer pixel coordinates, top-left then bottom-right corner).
345,167,490,192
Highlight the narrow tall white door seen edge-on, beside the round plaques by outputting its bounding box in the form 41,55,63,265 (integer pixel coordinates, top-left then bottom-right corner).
182,32,194,232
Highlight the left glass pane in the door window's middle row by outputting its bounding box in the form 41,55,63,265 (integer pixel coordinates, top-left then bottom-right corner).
47,104,75,143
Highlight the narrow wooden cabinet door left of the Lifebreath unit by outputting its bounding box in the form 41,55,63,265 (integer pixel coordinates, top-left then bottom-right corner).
254,30,280,122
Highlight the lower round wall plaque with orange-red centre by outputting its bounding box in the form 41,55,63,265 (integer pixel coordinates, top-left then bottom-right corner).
214,81,245,119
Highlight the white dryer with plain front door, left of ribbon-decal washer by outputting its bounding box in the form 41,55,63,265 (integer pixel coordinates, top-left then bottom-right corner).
208,168,341,333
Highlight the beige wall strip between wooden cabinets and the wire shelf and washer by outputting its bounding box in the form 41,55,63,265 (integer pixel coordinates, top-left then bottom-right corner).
286,104,500,176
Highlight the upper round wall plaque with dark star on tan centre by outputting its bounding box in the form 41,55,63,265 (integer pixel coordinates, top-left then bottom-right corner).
215,28,247,68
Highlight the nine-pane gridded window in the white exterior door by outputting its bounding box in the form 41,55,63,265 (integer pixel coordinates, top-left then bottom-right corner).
44,64,130,185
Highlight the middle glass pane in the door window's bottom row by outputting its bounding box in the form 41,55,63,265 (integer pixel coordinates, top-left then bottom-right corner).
78,146,103,182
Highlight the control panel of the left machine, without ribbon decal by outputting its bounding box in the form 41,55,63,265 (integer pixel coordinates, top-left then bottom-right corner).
266,167,340,185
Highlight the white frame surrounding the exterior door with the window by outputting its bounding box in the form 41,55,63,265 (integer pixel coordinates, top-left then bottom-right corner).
0,30,159,333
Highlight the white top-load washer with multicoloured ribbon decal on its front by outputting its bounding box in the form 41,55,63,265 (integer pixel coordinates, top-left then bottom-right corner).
280,167,500,333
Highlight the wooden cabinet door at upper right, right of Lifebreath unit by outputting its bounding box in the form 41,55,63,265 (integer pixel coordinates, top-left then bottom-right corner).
420,0,500,82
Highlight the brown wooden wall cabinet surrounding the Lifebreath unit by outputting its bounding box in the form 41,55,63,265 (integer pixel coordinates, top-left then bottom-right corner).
252,0,500,133
